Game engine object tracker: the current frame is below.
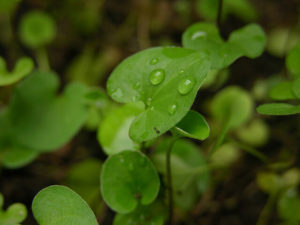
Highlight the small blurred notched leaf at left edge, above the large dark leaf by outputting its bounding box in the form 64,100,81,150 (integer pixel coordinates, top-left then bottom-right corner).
0,57,34,86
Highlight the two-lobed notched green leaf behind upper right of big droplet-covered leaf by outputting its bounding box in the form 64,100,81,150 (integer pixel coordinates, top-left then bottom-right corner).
182,23,266,69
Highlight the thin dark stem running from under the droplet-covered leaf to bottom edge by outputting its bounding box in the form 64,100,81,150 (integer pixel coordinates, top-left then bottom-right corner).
166,136,179,225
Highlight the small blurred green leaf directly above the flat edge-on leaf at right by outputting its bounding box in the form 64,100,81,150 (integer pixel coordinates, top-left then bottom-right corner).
270,81,296,100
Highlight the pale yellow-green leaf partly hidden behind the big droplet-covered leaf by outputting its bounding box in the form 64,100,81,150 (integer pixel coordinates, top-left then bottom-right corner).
98,102,144,155
